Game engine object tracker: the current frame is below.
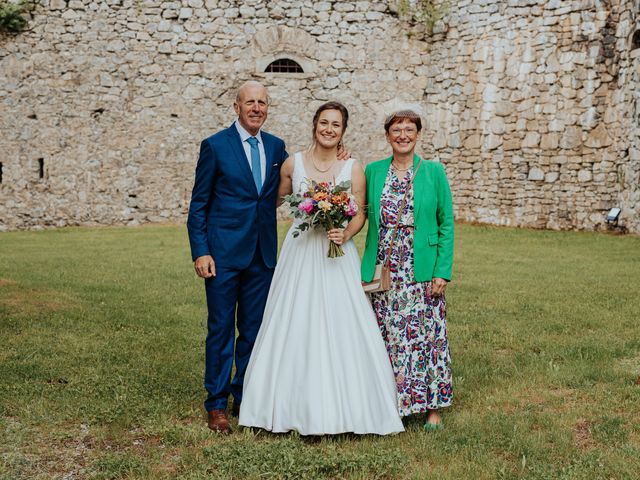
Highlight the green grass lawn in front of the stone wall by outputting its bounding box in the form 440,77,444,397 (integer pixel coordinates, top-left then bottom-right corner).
0,224,640,480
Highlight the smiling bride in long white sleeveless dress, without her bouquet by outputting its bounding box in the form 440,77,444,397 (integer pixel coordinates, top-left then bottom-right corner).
239,102,404,435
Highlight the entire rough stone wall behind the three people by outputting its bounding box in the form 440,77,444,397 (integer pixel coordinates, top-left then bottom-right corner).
0,0,640,232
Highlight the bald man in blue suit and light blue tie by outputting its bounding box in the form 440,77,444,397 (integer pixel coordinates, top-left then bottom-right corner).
187,81,287,433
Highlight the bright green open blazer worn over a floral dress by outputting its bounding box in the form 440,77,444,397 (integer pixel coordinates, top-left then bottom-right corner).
361,154,453,282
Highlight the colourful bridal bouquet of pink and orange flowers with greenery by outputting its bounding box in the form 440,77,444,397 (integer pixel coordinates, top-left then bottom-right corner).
284,180,358,258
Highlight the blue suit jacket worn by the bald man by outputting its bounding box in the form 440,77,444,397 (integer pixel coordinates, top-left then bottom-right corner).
187,125,287,269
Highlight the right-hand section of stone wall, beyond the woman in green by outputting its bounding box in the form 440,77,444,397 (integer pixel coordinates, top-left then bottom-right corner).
425,0,640,232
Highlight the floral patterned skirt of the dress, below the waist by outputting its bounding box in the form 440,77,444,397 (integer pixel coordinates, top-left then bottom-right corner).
371,226,453,416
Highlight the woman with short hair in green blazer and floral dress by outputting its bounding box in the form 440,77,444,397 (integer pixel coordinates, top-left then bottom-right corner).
362,110,453,430
